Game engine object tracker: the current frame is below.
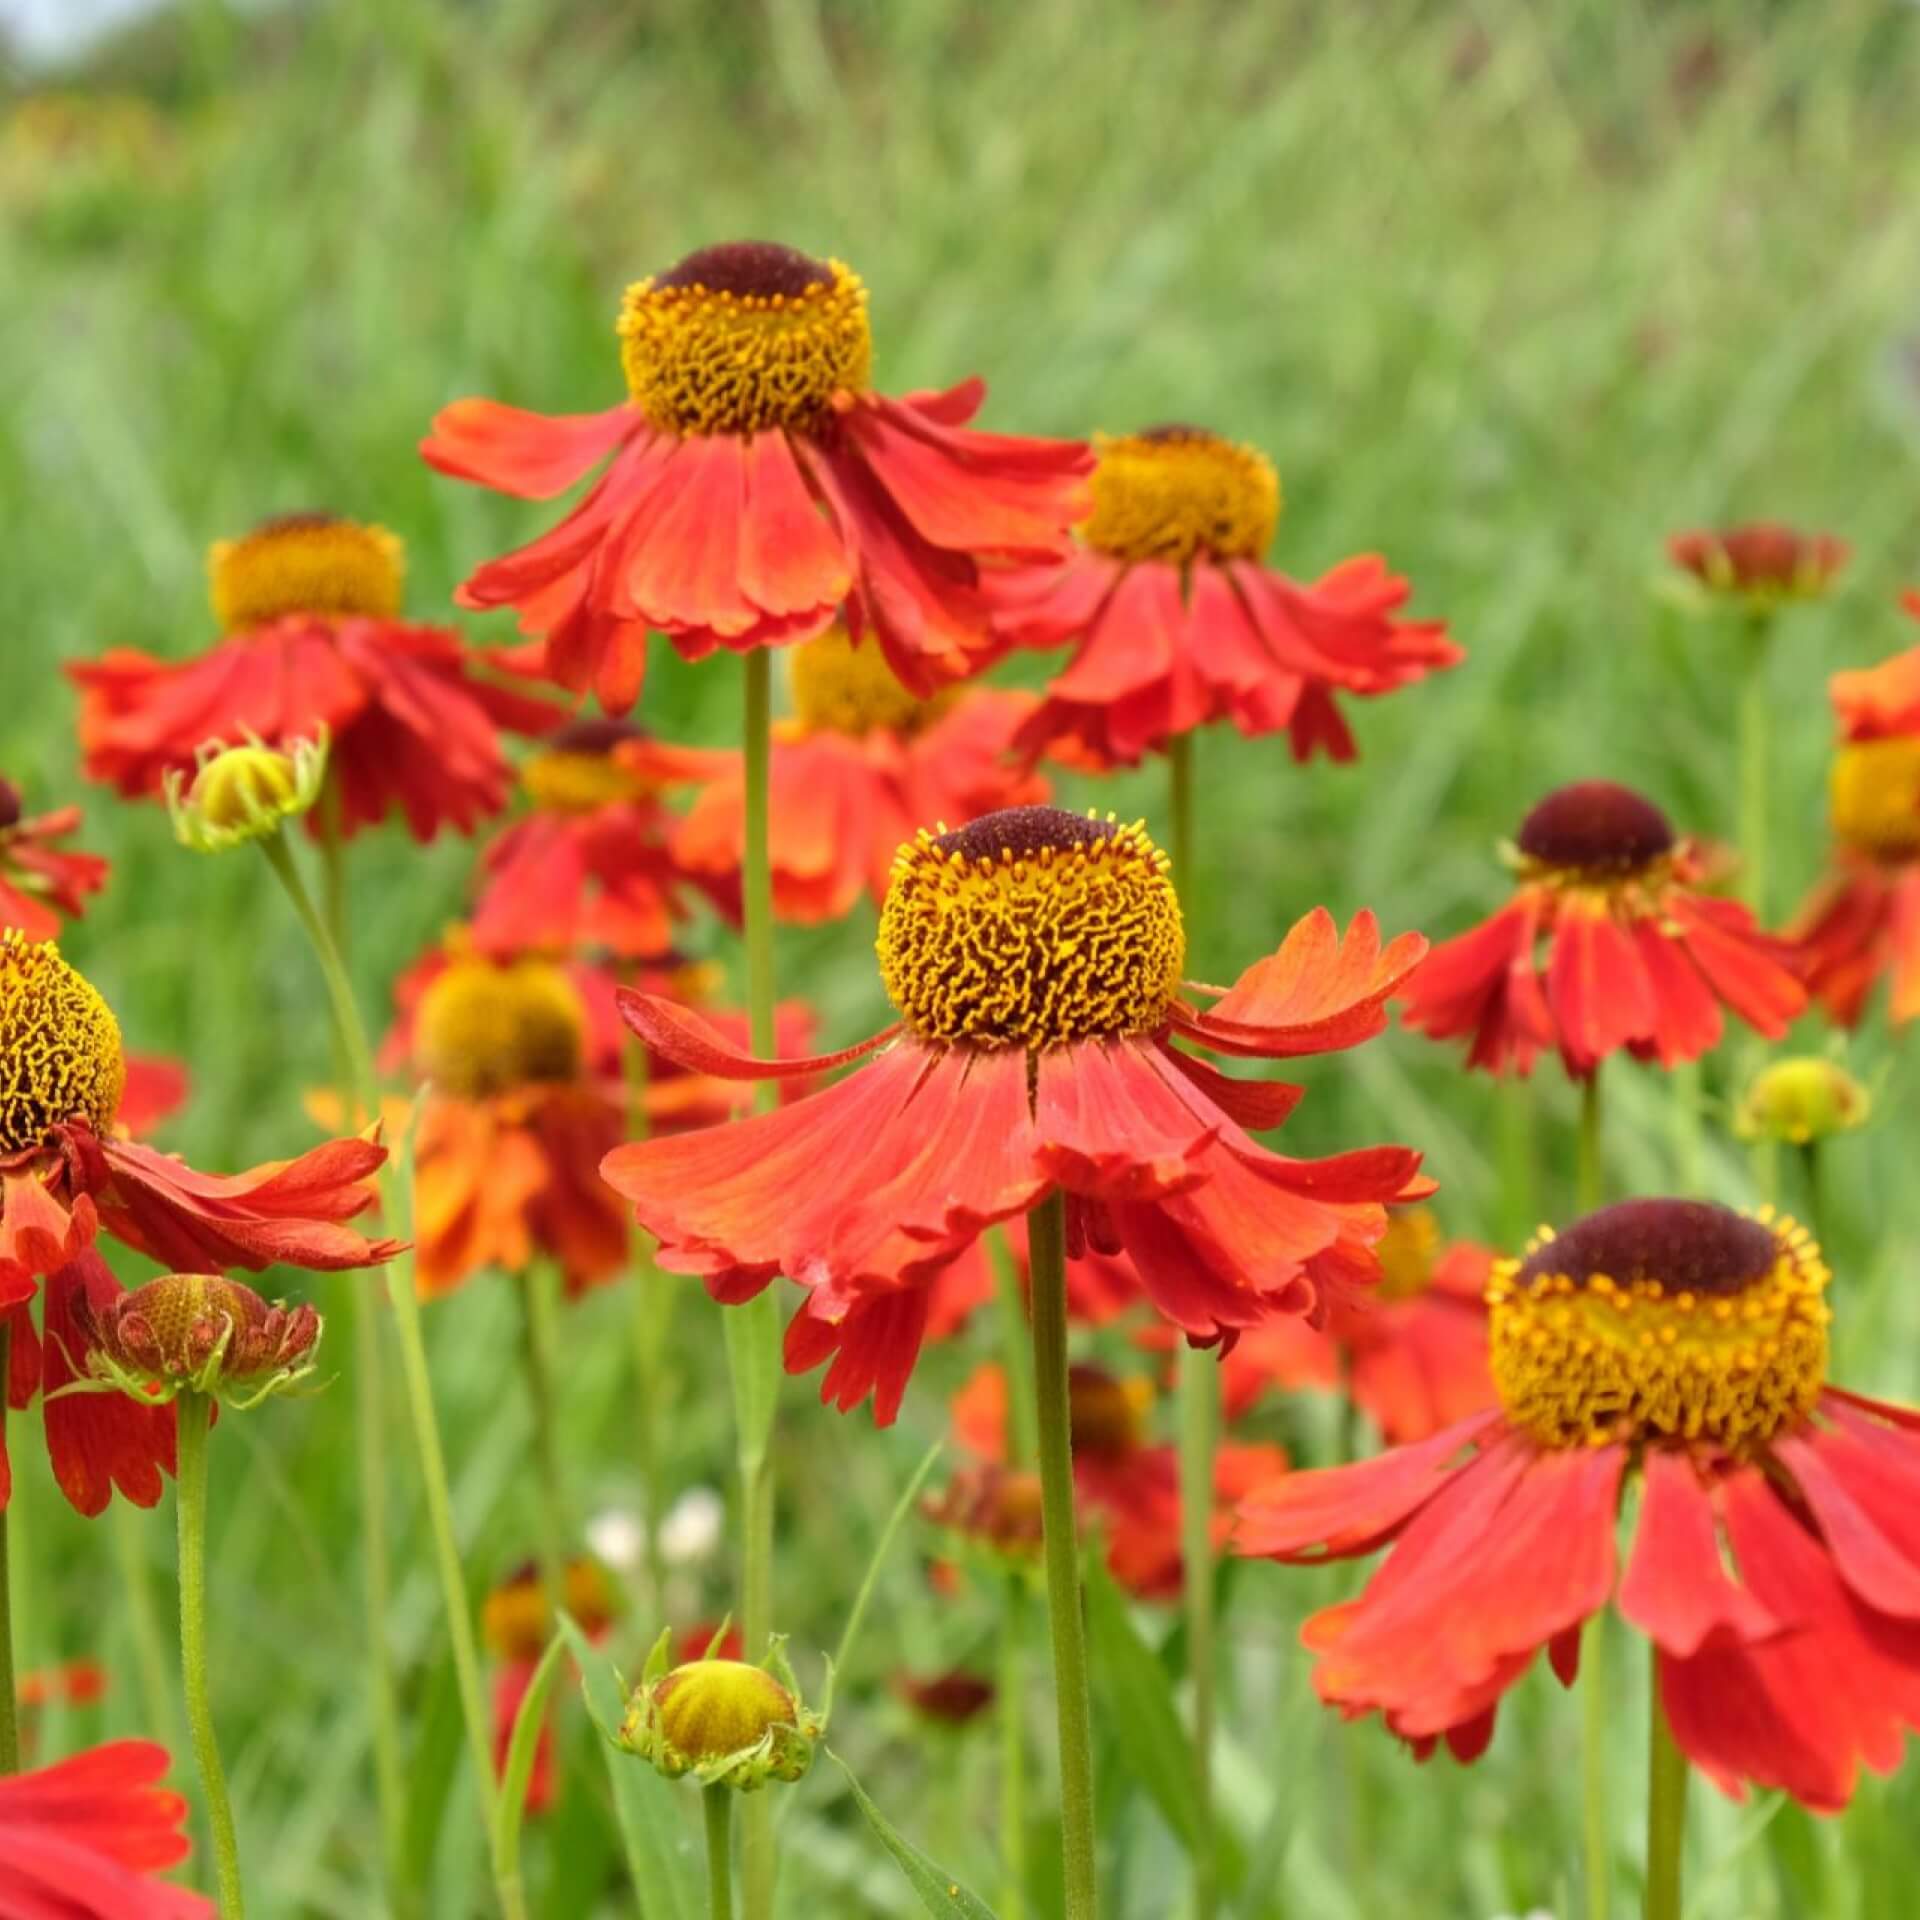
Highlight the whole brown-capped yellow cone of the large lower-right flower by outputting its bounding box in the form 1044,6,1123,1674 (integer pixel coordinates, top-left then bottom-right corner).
1488,1200,1830,1453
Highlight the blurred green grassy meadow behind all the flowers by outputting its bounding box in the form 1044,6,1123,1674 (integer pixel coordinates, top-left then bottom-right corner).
0,0,1920,1920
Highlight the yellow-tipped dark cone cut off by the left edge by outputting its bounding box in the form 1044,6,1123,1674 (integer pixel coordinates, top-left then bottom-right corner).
0,927,127,1154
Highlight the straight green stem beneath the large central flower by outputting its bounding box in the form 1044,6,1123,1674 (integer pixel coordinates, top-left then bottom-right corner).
1027,1192,1100,1920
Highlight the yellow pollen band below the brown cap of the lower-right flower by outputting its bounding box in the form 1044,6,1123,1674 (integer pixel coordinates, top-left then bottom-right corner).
1486,1213,1832,1455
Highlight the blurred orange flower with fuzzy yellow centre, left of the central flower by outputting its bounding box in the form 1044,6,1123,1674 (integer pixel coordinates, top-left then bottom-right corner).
384,933,808,1296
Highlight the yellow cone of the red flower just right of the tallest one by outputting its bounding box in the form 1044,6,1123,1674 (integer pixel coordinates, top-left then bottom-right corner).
1081,426,1281,564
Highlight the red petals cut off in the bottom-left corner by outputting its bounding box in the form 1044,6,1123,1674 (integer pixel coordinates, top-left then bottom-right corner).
0,1740,213,1920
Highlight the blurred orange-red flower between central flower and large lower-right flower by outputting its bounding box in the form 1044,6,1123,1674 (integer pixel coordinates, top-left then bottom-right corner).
1221,1208,1494,1446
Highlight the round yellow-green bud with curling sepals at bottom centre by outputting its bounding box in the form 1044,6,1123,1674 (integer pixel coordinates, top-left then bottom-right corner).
620,1630,824,1793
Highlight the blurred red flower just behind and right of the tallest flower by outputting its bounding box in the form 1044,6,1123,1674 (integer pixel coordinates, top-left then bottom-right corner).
993,426,1465,766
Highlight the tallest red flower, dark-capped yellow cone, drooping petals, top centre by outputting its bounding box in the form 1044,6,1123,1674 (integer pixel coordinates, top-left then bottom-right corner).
420,242,1092,712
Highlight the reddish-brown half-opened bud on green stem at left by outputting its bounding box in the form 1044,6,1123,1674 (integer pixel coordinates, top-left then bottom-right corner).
88,1273,323,1411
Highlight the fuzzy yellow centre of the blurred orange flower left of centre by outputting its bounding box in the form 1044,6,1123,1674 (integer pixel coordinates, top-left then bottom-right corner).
413,956,586,1100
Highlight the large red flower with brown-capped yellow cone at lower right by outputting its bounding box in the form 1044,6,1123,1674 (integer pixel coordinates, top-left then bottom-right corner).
1236,1200,1920,1811
